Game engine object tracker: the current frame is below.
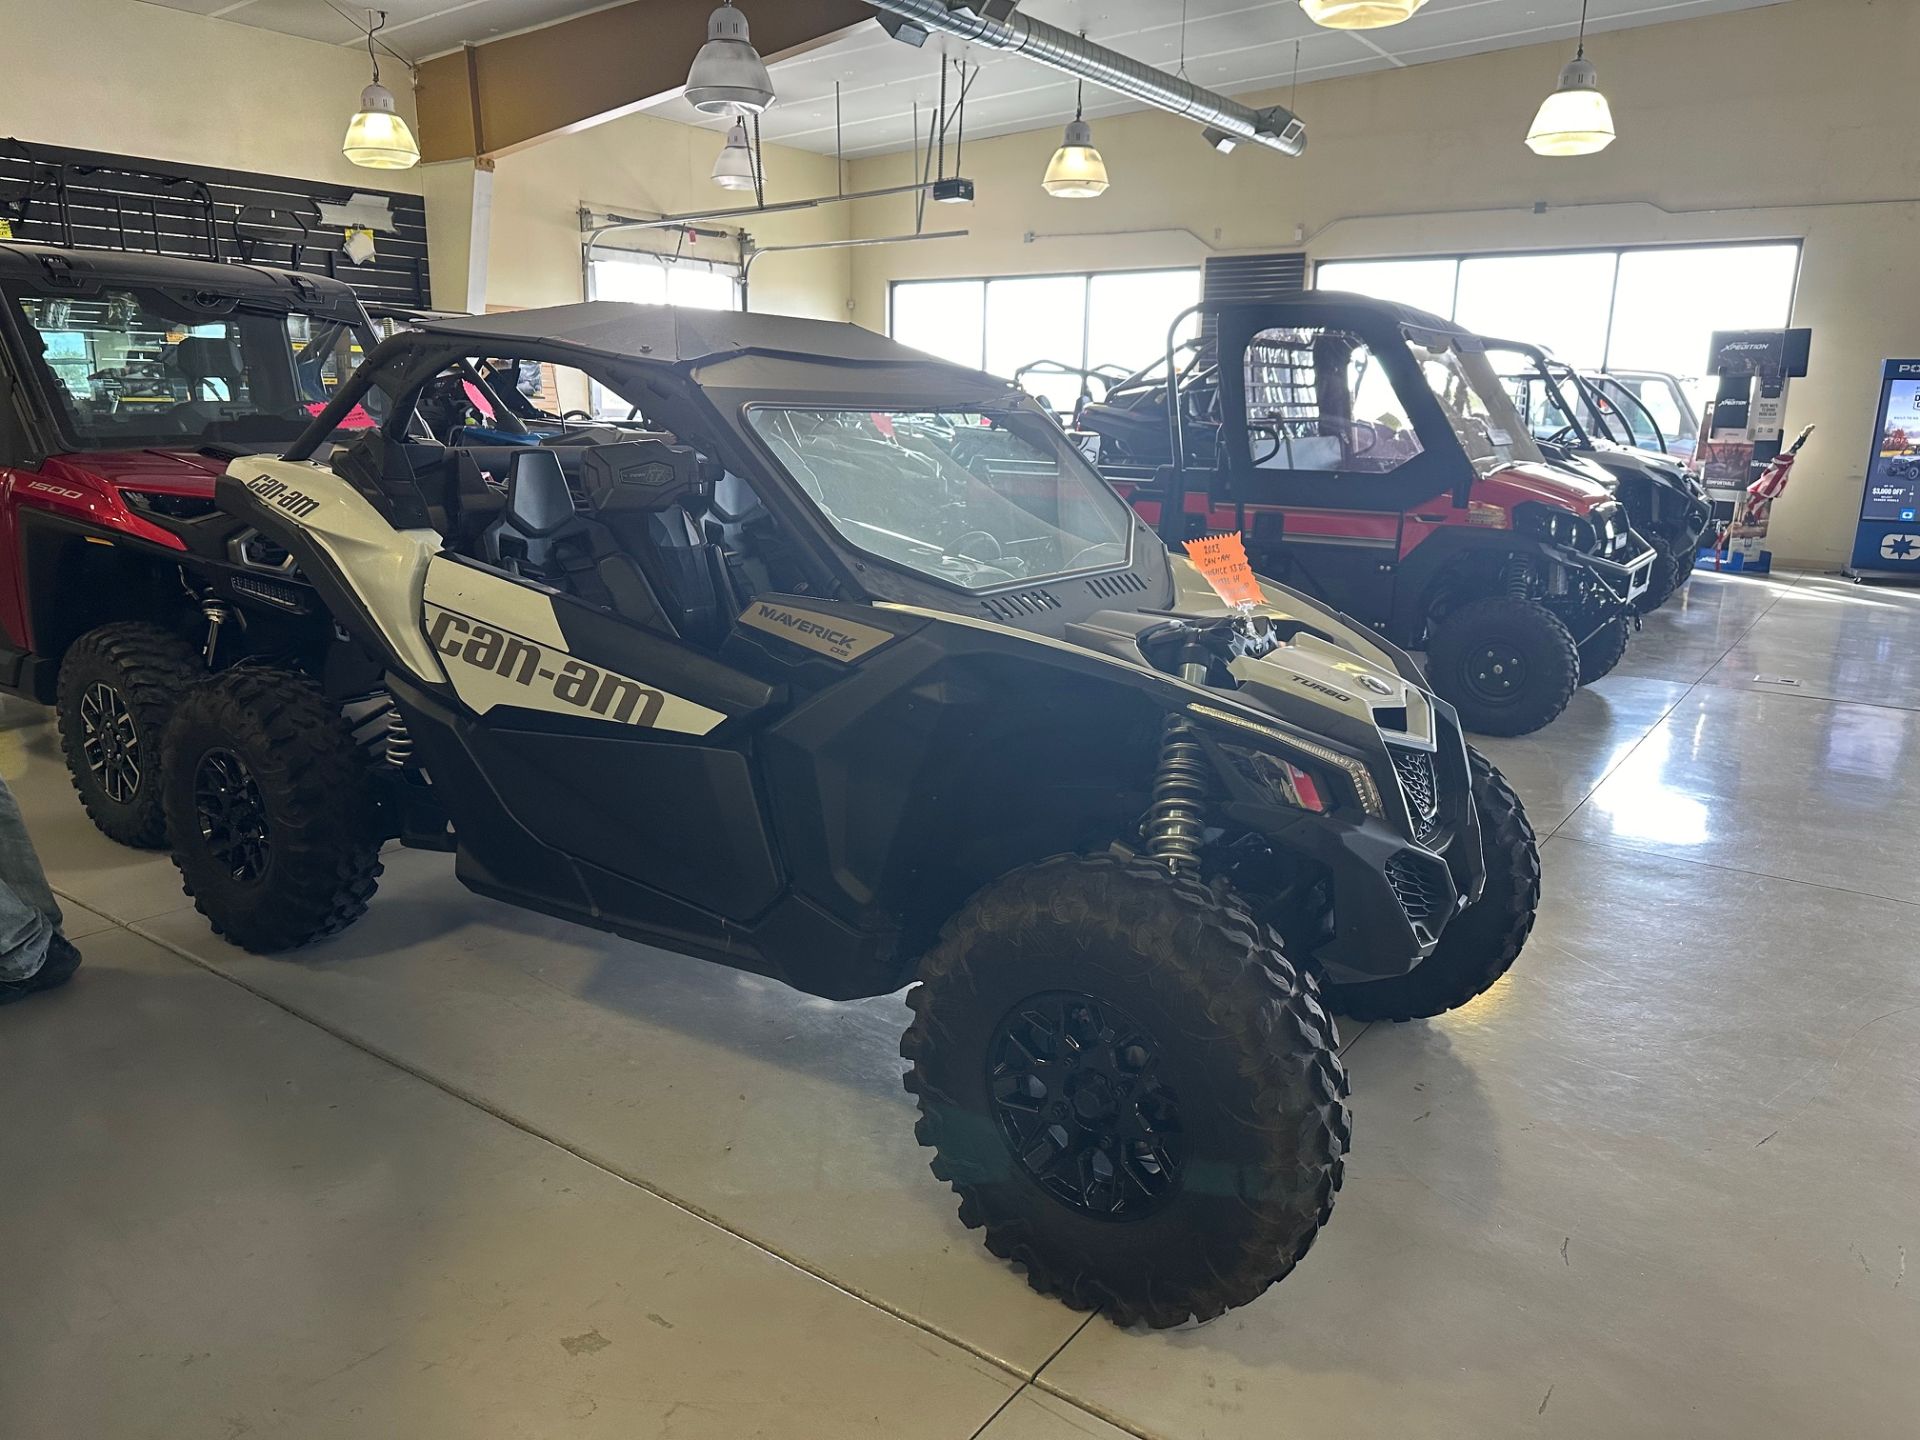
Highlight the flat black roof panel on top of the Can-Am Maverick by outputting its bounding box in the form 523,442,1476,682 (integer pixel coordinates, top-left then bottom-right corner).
419,300,977,376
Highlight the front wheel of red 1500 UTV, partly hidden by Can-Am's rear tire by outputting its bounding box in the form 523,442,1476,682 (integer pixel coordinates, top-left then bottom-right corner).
54,620,207,851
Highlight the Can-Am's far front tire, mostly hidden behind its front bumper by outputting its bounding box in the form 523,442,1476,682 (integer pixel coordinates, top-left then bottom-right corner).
1325,745,1540,1020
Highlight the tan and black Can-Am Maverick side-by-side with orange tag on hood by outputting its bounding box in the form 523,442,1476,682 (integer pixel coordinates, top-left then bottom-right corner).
163,303,1540,1325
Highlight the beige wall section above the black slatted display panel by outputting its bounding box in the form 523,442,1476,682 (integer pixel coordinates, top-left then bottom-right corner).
0,0,419,190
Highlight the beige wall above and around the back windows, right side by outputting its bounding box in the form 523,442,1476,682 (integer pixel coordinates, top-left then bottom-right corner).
852,0,1920,564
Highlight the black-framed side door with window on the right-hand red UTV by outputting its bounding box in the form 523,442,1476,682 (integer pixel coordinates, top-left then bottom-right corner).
1212,311,1452,618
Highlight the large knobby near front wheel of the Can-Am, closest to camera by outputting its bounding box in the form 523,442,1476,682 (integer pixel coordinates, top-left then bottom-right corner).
900,856,1352,1327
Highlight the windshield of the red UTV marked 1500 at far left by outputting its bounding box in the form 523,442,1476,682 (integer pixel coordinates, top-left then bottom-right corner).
10,286,372,449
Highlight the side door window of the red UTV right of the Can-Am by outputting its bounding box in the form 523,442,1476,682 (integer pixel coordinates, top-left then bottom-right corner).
1246,330,1421,474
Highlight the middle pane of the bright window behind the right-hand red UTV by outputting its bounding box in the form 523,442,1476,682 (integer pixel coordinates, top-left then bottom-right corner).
1453,252,1615,365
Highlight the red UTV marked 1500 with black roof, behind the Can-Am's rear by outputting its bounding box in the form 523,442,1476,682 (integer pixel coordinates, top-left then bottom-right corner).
0,240,374,847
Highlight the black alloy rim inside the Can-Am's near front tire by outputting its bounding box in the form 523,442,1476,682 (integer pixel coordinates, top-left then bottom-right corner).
987,991,1185,1221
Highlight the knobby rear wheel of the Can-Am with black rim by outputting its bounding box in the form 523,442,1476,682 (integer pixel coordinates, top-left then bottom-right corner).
165,668,380,954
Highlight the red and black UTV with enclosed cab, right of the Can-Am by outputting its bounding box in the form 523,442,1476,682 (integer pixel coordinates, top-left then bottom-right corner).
1081,290,1655,735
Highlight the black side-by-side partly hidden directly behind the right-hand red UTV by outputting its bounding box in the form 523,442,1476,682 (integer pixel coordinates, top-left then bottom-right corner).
1486,340,1713,614
